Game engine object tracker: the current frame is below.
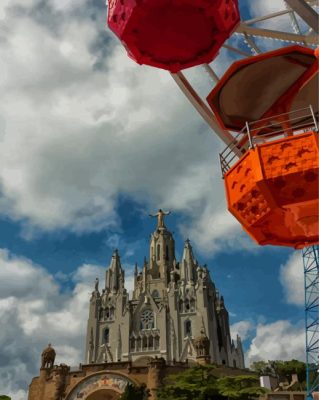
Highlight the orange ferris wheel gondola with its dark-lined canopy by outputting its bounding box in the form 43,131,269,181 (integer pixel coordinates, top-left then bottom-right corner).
207,46,319,248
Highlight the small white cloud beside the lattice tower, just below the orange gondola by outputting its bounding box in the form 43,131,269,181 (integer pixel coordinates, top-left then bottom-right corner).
280,252,305,306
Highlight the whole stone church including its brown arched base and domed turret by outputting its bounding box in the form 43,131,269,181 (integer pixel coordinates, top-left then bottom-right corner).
28,210,246,400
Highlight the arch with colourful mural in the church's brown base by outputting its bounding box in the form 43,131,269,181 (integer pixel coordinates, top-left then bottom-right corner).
65,371,136,400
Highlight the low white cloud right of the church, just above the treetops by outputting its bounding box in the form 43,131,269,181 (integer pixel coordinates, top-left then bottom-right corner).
245,320,305,365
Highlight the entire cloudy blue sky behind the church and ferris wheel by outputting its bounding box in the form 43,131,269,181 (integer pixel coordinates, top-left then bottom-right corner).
0,0,316,400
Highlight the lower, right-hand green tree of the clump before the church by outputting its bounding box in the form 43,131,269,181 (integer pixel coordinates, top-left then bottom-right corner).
217,375,267,400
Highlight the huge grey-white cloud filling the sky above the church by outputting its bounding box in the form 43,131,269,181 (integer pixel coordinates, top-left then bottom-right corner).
0,0,262,251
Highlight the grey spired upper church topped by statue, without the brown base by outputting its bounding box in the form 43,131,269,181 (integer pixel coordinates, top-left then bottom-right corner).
85,210,244,368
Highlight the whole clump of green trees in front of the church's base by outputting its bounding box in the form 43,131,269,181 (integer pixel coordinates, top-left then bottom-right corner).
157,365,266,400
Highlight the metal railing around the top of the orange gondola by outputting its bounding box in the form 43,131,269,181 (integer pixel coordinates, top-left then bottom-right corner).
219,105,319,176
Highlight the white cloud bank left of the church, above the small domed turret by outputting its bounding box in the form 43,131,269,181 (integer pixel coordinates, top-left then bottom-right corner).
0,249,109,400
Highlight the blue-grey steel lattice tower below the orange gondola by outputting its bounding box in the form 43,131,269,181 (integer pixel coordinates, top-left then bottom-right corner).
302,246,319,400
